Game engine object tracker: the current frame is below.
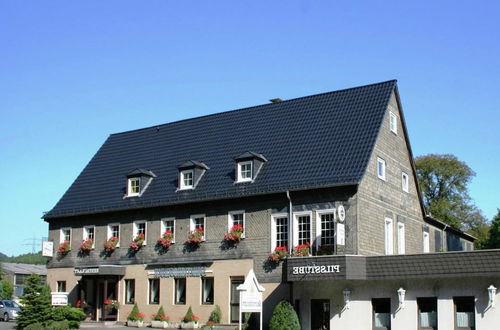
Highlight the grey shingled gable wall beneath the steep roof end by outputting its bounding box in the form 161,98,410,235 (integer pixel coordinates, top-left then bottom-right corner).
358,92,435,255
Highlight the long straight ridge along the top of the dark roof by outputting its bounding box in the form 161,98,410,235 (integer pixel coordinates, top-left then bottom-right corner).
109,79,397,136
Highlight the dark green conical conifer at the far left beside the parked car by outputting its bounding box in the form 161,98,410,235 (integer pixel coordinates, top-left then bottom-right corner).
16,274,52,329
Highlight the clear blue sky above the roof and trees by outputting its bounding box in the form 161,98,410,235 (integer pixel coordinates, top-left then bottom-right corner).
0,0,500,255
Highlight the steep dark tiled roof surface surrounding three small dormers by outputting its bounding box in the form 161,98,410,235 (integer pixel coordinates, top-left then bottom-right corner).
44,80,396,219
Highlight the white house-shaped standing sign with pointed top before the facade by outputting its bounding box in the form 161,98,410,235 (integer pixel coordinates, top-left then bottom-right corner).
236,269,266,330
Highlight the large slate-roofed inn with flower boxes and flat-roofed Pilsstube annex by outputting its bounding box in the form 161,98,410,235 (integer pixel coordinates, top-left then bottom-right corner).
44,81,500,329
